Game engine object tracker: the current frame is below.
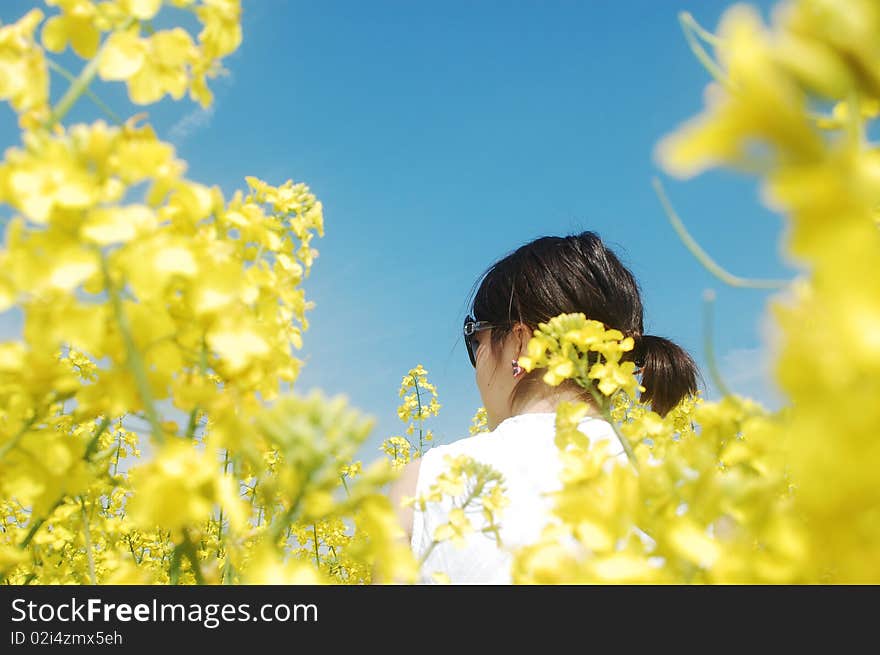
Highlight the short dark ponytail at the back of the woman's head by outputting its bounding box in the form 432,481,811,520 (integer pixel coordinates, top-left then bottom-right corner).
634,334,699,416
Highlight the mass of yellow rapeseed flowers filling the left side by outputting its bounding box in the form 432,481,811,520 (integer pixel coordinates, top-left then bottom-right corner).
0,0,415,584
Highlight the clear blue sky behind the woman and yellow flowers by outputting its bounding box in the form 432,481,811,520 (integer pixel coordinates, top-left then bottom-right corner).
0,0,796,461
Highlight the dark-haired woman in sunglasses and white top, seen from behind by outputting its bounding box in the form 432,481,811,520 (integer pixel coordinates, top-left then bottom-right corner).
390,232,698,584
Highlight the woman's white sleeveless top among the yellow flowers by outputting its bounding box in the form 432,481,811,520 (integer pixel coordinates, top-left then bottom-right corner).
410,412,626,584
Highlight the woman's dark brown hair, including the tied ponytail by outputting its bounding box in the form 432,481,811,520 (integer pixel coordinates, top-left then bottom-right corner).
471,231,700,416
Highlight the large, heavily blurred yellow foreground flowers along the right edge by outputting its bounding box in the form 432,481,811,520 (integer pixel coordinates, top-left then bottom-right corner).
658,0,880,582
